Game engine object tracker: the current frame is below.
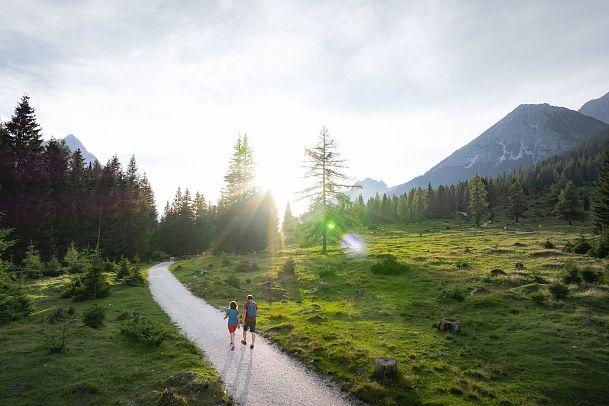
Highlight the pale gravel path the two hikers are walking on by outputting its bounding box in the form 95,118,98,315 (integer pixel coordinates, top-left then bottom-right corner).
148,262,351,406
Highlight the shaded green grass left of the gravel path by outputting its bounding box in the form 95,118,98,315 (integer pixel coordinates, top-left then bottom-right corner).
0,266,230,405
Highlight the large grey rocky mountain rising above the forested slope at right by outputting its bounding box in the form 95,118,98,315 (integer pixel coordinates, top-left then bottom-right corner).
390,104,609,195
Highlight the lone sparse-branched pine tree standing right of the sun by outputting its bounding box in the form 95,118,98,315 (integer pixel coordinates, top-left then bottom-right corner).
302,127,358,254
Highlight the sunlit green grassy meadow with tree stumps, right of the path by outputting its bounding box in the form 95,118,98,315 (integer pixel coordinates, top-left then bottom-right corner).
174,222,609,405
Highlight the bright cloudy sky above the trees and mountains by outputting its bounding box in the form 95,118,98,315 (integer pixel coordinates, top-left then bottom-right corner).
0,0,609,216
